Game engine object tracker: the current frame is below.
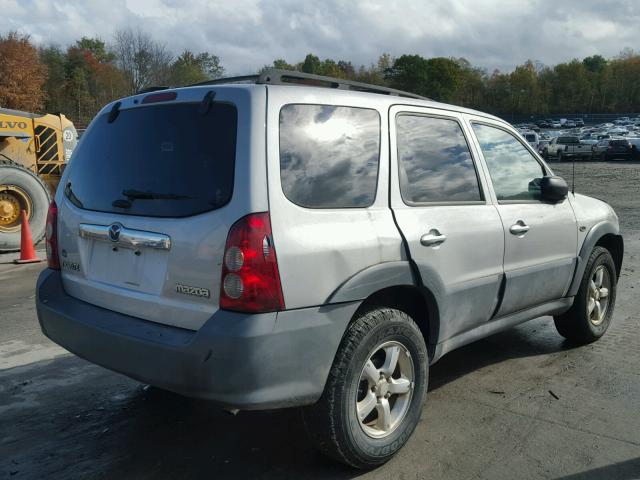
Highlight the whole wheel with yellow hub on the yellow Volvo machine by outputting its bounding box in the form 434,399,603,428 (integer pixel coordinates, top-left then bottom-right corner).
0,160,50,251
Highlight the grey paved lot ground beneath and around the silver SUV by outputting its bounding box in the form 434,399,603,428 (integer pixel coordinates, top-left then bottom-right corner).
0,162,640,480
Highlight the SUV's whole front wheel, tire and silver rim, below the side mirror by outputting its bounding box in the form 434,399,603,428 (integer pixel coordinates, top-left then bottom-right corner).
554,247,617,344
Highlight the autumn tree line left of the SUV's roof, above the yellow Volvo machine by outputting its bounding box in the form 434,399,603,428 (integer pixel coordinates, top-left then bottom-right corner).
0,29,224,126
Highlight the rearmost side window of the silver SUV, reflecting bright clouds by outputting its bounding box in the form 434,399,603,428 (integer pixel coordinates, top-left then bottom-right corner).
280,105,380,208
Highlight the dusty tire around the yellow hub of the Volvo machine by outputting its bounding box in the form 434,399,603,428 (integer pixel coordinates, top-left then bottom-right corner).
0,160,50,252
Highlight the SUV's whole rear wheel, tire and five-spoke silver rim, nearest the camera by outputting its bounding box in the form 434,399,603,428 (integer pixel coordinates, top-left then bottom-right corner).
302,308,429,469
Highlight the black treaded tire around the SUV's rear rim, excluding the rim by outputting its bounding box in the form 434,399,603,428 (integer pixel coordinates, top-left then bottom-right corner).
303,308,428,468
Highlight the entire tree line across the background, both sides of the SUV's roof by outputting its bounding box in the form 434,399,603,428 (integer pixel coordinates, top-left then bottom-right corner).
0,29,640,125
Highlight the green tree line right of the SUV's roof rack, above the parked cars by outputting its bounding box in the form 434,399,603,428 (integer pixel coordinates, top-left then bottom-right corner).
263,49,640,115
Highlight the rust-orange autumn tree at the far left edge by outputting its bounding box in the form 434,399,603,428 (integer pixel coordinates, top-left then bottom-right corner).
0,32,47,112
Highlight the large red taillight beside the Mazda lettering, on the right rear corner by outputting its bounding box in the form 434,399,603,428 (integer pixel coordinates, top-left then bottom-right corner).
220,212,284,313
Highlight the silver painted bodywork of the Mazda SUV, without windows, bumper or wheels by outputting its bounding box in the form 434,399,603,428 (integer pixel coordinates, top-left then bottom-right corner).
50,85,618,372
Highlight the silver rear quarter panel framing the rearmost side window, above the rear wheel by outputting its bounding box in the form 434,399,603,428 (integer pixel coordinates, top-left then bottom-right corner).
267,86,405,309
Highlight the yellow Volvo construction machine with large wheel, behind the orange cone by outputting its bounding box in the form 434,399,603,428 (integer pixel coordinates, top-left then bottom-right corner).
0,108,78,251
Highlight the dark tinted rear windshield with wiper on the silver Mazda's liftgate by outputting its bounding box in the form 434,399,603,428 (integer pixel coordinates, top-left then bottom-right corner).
64,103,237,217
